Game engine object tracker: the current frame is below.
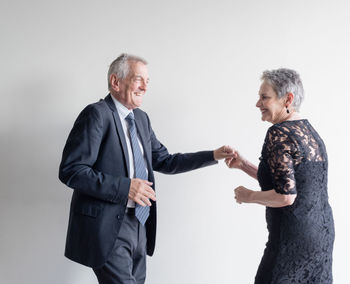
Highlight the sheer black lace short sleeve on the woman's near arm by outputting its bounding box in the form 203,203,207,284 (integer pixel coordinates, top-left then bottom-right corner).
266,126,297,194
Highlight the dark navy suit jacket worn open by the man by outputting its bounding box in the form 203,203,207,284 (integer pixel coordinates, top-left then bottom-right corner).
59,95,216,268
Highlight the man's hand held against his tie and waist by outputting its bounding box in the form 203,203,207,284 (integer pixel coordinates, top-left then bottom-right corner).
129,178,156,207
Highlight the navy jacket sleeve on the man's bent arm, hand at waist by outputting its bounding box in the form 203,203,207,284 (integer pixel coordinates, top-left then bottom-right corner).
59,105,130,204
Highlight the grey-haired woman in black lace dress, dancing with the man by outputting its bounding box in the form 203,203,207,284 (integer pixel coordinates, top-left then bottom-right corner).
226,69,334,284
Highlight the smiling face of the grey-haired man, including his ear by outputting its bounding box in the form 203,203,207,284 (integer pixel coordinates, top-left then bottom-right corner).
110,61,149,109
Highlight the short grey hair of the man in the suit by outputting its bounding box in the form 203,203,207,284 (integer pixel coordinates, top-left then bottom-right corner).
107,53,147,90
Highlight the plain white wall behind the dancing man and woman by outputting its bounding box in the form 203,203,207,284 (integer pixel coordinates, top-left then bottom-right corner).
0,0,350,284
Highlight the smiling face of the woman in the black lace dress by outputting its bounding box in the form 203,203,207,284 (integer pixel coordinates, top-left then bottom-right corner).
256,81,286,123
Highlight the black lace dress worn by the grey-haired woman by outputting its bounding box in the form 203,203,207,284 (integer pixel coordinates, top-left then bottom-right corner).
255,119,334,284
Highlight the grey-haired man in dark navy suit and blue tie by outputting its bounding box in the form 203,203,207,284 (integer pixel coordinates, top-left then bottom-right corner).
59,54,232,284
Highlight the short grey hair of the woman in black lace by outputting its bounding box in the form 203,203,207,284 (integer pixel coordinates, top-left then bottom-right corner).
261,68,304,111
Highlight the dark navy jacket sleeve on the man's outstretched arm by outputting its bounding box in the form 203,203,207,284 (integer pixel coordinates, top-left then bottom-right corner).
147,113,218,174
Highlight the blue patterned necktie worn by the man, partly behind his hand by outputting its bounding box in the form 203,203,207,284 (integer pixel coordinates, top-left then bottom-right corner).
125,112,149,225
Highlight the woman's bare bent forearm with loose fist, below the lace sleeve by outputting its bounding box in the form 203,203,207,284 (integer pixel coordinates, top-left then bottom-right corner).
235,186,297,208
